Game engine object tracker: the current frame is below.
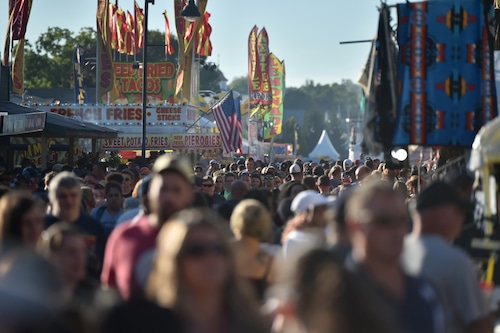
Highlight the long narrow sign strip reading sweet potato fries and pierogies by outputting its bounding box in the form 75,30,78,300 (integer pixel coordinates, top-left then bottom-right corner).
101,133,222,150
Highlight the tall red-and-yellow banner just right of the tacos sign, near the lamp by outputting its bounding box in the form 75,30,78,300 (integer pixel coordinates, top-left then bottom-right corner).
175,0,208,101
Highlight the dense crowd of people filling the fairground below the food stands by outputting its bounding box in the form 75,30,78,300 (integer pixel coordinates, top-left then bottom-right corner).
0,154,497,333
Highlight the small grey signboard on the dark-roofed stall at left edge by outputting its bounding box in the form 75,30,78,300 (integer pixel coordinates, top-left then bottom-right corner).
1,112,47,135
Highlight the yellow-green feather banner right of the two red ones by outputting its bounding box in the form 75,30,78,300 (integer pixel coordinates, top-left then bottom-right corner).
264,53,285,139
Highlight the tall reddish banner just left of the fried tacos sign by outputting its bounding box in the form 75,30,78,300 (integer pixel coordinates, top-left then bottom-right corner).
97,0,118,103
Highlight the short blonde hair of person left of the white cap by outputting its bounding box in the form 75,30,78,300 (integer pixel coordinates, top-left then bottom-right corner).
231,199,272,241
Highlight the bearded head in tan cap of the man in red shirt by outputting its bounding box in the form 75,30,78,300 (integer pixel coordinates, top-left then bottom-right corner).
148,154,194,224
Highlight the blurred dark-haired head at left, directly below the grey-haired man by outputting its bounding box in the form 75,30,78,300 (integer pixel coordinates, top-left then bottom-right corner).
39,222,87,288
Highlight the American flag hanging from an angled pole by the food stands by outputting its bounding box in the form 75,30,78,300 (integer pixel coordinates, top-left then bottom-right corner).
212,90,242,153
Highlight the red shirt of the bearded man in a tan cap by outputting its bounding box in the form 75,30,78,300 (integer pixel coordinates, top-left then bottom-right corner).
101,215,160,299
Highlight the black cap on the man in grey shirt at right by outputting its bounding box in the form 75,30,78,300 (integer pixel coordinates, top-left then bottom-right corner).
415,181,470,212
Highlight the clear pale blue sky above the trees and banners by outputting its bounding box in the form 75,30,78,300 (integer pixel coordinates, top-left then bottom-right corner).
0,0,402,87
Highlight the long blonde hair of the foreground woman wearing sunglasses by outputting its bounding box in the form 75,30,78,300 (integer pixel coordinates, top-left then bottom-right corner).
146,209,269,333
